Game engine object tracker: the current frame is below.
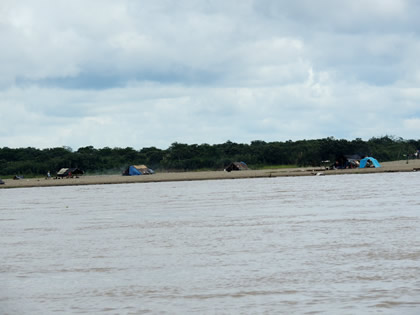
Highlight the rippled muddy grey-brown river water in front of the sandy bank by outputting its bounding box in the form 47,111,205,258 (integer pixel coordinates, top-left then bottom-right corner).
0,173,420,314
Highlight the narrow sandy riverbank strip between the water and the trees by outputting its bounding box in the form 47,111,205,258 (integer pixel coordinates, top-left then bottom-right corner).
0,159,420,189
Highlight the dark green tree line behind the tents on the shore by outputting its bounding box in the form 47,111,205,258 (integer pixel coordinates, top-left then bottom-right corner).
0,136,420,176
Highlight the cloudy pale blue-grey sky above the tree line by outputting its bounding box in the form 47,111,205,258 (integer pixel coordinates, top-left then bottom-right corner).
0,0,420,149
